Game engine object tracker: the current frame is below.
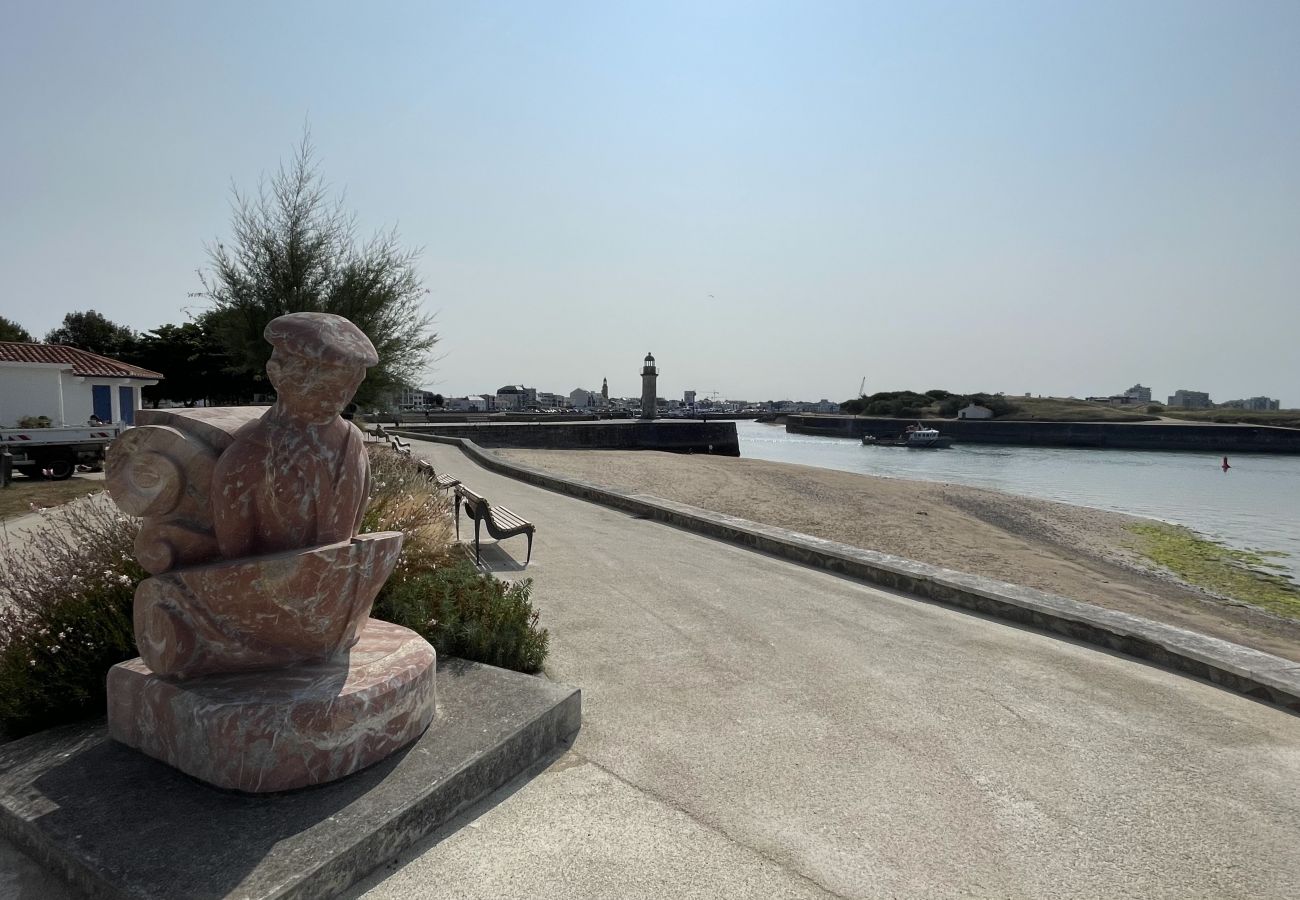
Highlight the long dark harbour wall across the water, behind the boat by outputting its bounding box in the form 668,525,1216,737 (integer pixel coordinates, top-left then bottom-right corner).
785,415,1300,454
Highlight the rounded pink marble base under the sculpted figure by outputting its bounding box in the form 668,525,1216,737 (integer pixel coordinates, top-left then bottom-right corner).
108,619,437,793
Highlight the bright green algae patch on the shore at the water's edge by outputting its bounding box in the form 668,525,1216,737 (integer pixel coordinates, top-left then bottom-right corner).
1127,523,1300,619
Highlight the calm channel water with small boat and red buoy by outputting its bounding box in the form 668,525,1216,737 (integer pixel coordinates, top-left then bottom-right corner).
736,421,1300,579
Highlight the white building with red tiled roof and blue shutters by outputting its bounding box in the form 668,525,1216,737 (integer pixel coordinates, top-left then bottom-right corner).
0,341,163,428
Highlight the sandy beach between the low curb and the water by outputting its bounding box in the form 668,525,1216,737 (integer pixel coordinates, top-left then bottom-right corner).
497,450,1300,661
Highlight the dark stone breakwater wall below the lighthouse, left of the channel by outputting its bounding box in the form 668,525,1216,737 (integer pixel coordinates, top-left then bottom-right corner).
399,419,740,457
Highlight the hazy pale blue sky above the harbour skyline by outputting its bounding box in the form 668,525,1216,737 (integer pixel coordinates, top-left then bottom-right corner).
0,0,1300,406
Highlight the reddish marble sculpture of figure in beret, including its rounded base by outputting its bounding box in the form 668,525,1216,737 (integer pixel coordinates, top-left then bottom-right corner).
107,312,436,792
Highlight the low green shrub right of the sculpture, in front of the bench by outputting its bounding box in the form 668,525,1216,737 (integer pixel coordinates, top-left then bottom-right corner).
374,561,550,672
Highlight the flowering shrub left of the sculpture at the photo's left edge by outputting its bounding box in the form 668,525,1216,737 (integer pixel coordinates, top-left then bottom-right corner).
0,496,146,736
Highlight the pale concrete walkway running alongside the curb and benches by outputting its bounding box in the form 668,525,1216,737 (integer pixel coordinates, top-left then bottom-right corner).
352,442,1300,899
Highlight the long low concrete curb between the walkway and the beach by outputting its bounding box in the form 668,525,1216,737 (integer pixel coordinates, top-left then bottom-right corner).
403,432,1300,714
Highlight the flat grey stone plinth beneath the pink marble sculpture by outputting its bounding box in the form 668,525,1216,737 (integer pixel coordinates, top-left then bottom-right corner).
0,659,582,900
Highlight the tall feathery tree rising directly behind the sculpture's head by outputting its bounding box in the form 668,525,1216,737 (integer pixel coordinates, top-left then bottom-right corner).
199,134,438,403
